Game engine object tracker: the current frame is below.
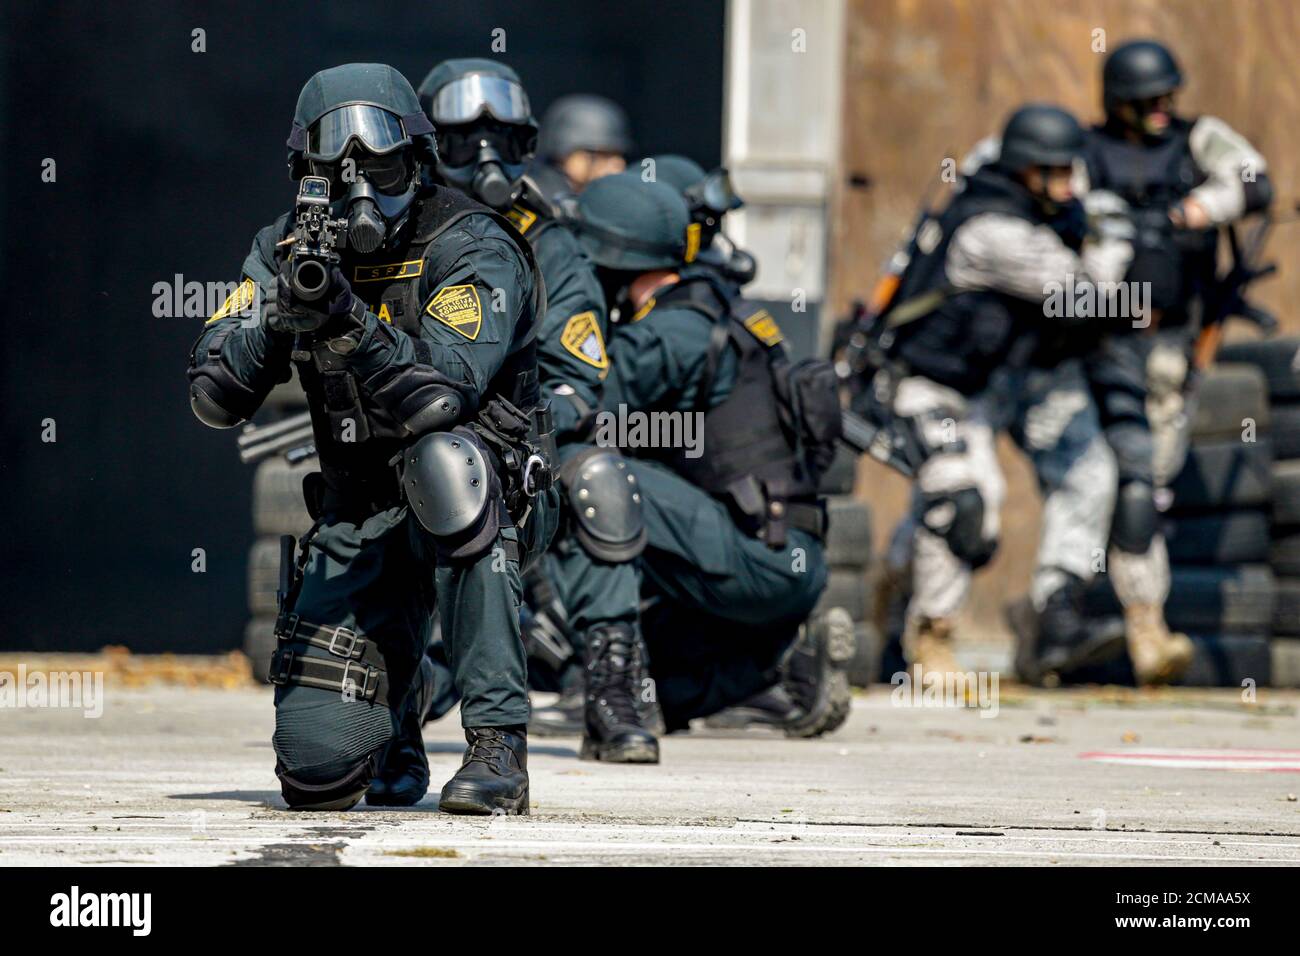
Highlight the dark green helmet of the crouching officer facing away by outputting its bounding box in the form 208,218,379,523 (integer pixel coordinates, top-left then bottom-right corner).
575,172,690,272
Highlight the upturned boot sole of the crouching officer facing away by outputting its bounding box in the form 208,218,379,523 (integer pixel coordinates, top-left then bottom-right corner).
781,607,857,737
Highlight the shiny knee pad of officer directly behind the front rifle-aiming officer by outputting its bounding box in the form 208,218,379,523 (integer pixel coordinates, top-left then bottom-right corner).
560,447,646,562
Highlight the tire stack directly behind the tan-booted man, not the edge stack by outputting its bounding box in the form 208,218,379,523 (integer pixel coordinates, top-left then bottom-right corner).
1076,363,1275,687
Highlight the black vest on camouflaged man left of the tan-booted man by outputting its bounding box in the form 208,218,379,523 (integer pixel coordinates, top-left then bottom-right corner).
885,166,1043,395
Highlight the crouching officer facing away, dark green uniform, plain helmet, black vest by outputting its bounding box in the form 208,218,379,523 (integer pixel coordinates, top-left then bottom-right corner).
577,173,852,730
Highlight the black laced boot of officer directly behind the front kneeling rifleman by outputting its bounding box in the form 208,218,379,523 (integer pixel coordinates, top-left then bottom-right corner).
581,624,659,763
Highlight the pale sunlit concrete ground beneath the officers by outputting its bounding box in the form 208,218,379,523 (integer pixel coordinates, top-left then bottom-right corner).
0,685,1300,866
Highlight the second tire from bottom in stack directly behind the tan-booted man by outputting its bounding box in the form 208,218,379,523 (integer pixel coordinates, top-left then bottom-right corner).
1084,564,1277,635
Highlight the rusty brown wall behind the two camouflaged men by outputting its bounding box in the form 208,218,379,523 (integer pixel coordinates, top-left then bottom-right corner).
829,0,1300,636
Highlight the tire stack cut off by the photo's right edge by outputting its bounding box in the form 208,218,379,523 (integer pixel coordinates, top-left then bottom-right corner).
1218,336,1300,687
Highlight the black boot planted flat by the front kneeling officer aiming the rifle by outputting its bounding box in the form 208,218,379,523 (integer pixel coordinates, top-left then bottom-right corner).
438,724,528,816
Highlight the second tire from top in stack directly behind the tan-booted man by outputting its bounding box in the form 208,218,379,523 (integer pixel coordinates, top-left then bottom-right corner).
1170,438,1273,515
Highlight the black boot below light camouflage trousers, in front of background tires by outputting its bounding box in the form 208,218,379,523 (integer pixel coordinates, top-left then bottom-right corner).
1006,574,1125,687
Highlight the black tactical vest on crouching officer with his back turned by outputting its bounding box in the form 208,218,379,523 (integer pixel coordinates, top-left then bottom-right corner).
633,274,816,546
